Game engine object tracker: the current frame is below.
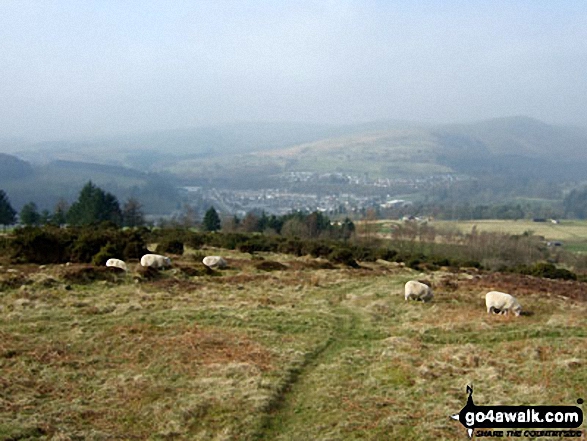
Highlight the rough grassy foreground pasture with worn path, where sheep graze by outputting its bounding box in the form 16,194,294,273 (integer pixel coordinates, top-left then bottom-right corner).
0,249,587,440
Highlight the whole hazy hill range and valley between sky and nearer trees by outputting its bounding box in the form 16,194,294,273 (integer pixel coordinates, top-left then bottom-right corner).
0,117,587,208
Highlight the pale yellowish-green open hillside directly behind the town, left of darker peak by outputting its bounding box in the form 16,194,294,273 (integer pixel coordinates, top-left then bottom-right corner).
165,130,451,184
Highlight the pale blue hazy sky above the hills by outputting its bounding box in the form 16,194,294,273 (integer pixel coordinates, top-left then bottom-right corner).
0,0,587,140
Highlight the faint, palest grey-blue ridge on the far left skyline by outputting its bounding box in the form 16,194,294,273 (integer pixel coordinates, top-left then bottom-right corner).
5,123,362,171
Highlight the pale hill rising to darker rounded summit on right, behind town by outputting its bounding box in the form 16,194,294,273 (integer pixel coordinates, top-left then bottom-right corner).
155,117,587,180
